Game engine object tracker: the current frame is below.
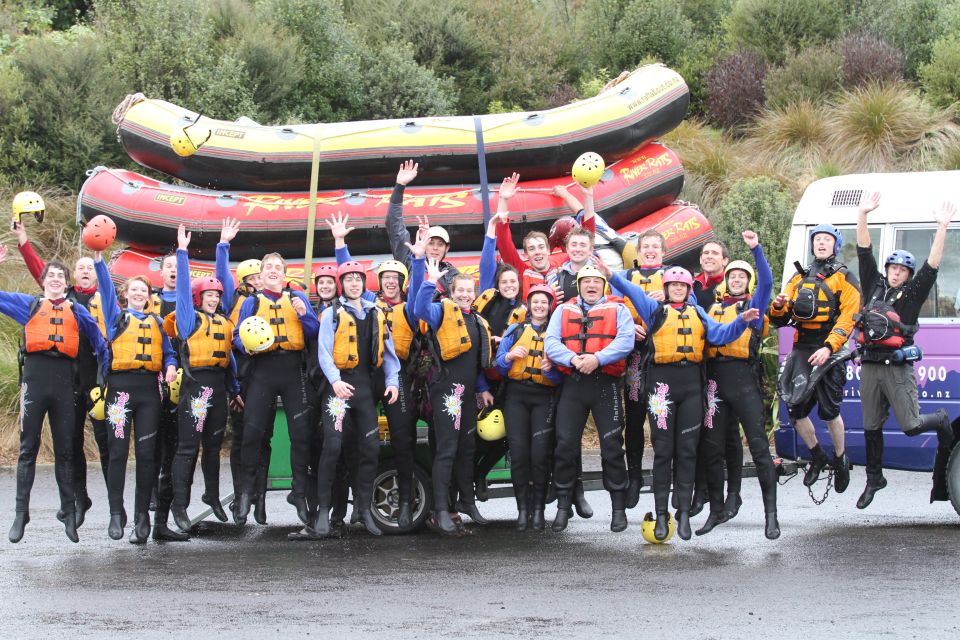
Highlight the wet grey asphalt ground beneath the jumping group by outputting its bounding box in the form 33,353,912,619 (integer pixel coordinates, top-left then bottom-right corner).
0,460,960,640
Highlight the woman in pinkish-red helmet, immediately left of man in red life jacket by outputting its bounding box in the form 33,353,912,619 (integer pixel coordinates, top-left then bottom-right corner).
496,284,563,531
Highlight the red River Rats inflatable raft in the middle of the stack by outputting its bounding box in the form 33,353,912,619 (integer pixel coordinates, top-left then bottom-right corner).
77,144,683,259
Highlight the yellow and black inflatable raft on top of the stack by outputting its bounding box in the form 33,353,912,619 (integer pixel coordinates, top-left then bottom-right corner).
114,65,690,191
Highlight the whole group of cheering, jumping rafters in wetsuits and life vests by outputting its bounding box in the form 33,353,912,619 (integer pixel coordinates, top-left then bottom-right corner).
0,161,954,544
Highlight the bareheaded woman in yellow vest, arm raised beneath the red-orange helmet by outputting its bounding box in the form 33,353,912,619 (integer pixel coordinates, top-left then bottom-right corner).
93,251,177,544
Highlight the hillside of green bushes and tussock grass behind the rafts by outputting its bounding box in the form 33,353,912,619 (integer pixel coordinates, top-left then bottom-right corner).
0,0,960,460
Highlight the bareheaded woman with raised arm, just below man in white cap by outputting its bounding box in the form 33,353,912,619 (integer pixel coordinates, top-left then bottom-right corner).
413,258,493,535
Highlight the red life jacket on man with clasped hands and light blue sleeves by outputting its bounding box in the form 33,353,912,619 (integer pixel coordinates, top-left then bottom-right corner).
558,296,627,378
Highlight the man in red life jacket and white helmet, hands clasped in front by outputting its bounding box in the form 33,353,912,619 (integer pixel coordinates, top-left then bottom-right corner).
544,262,634,531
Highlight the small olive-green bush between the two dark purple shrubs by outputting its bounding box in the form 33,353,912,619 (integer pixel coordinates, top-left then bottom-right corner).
763,45,843,109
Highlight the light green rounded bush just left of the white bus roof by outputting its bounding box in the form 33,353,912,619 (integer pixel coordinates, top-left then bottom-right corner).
710,176,796,290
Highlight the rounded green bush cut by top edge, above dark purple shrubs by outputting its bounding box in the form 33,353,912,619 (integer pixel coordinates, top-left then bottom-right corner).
726,0,844,64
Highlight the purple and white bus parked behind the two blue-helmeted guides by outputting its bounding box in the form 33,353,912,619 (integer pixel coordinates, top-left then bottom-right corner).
775,171,960,513
